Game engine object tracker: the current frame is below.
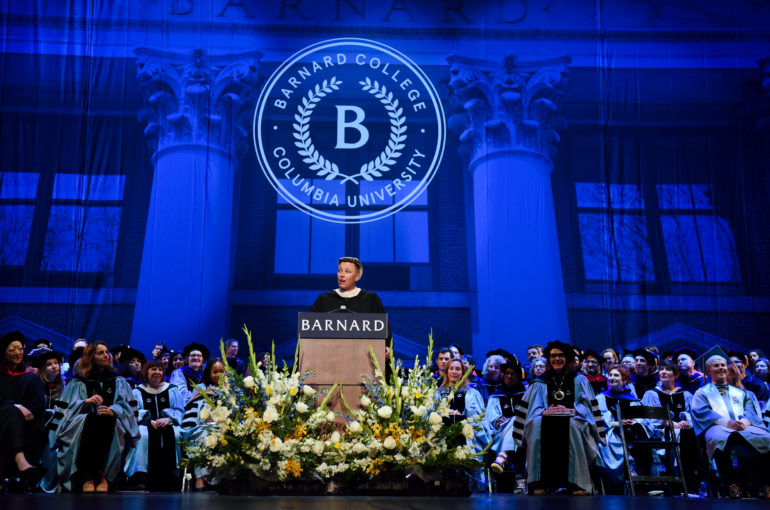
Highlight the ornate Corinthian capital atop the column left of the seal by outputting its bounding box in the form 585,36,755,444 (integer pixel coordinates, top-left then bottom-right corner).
135,48,262,155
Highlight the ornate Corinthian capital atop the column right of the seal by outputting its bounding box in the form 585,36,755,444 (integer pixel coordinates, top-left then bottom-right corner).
447,55,570,167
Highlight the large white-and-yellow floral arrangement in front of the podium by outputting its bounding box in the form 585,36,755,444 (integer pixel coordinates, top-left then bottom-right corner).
184,326,481,482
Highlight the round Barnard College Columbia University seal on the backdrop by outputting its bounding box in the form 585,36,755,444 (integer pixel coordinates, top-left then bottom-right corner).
254,39,446,223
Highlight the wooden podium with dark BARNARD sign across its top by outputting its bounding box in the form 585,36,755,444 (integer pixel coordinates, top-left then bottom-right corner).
297,312,388,411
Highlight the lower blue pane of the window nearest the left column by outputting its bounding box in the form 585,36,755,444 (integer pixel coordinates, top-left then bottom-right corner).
40,206,121,271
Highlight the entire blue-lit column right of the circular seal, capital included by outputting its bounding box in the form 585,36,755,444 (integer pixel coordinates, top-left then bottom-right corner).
448,56,570,363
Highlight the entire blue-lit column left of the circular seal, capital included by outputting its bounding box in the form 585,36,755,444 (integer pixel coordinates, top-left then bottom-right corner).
131,48,261,352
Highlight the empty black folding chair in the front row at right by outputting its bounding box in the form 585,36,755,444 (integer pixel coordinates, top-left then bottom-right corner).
618,406,687,496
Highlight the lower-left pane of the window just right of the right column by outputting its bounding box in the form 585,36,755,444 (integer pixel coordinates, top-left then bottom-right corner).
578,213,618,280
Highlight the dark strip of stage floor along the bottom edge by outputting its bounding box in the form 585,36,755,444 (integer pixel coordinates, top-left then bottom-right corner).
0,492,768,510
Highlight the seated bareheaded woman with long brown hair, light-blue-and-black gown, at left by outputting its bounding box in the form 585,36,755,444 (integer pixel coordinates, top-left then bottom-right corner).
56,342,139,492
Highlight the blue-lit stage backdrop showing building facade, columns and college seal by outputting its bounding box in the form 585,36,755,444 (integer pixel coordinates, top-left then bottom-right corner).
0,0,770,362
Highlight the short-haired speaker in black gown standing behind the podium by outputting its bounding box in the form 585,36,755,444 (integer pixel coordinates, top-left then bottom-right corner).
310,257,385,313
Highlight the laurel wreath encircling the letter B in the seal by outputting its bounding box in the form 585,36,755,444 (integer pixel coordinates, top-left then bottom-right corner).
292,76,407,184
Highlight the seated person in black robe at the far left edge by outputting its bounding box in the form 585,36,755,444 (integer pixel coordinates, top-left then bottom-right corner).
0,331,45,492
